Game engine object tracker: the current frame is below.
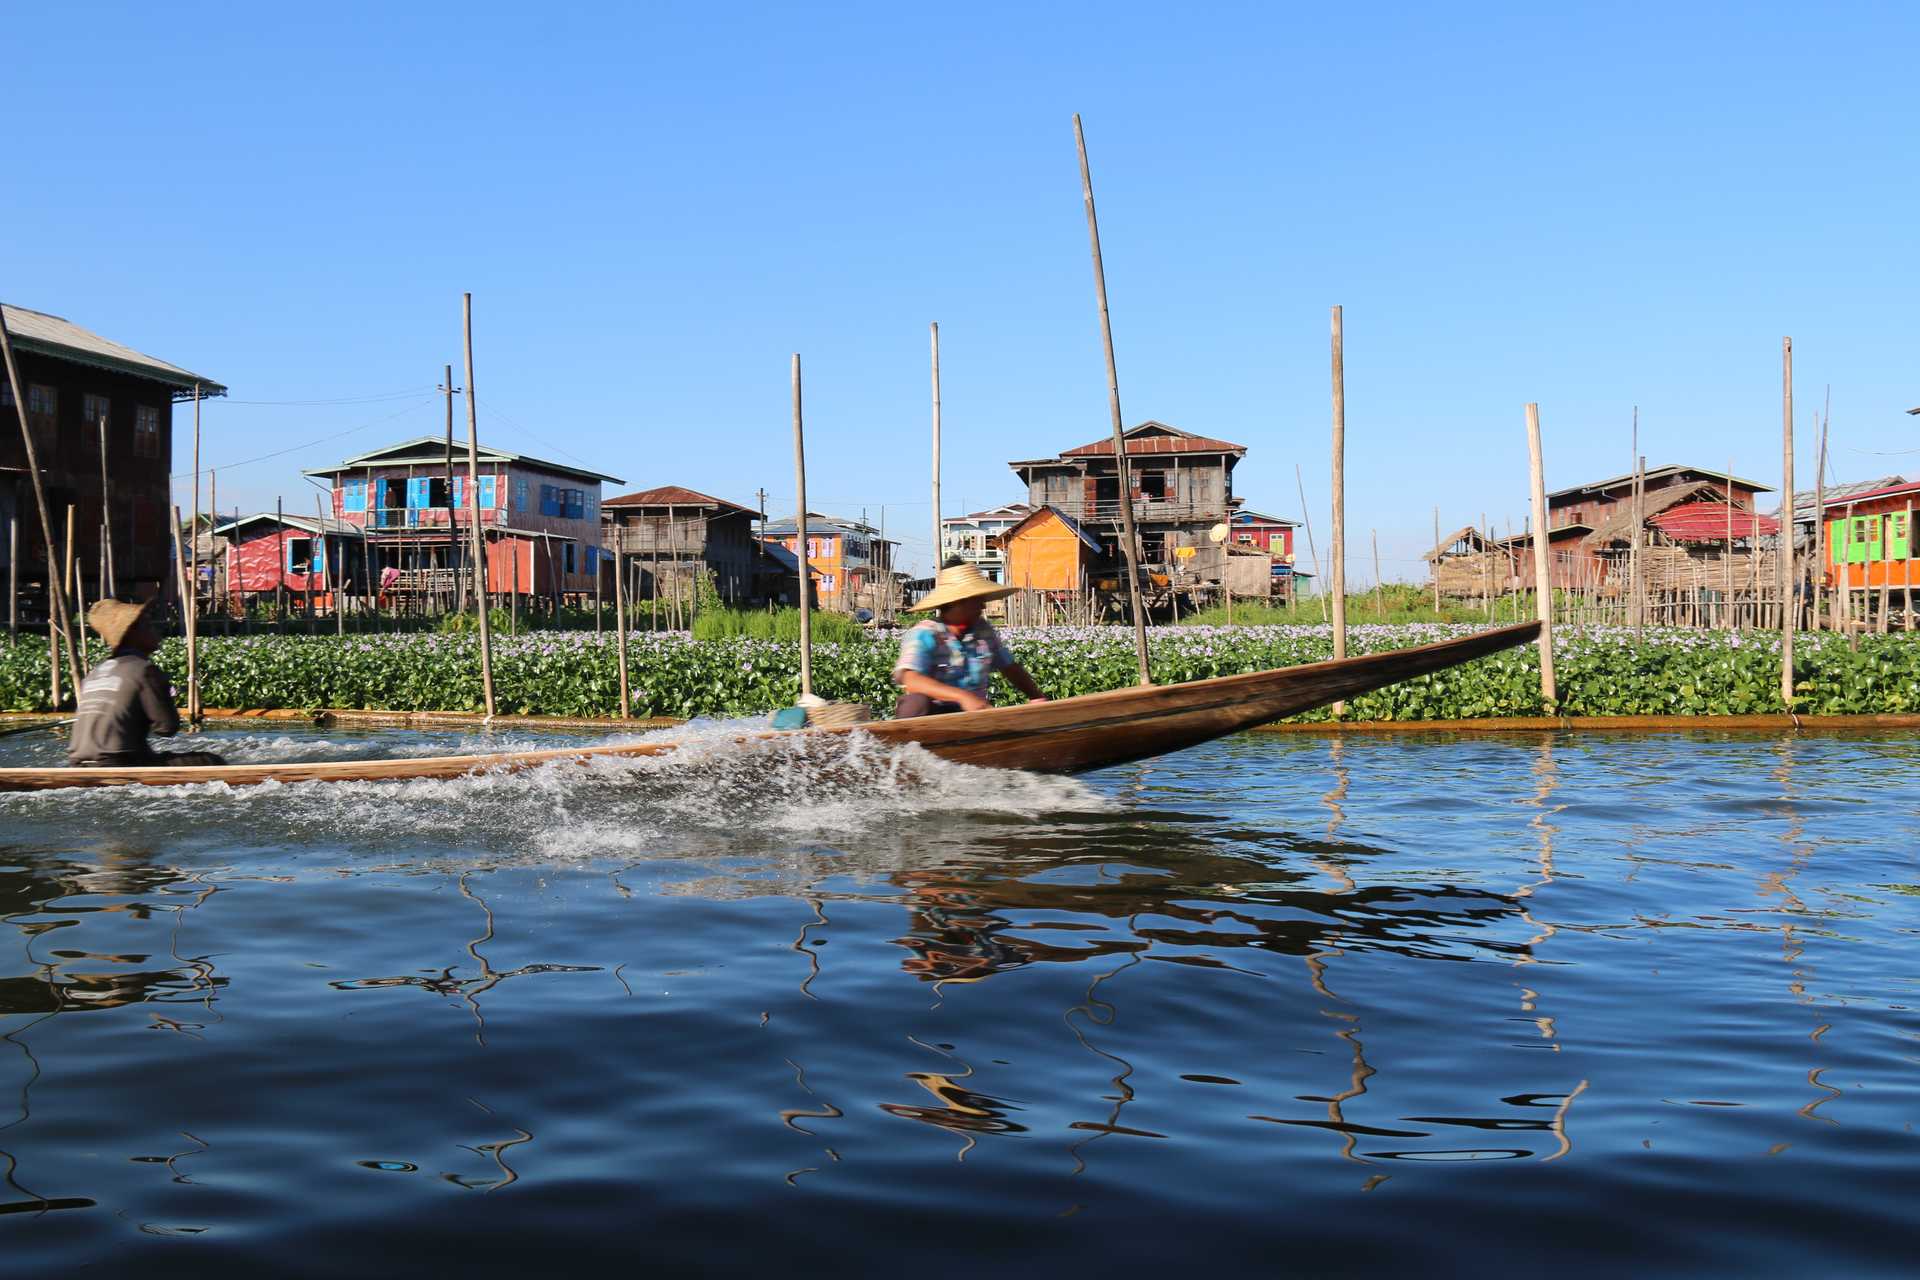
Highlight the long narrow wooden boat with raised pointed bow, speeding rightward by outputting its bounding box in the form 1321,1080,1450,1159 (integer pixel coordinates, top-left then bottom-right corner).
0,622,1540,791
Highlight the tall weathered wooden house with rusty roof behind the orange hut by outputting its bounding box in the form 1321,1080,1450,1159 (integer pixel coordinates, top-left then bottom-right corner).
1008,422,1246,587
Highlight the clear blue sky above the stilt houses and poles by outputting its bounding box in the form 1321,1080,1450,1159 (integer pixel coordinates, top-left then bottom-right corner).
0,4,1920,580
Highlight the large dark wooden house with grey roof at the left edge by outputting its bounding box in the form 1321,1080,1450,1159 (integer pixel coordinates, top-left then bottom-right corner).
0,307,227,618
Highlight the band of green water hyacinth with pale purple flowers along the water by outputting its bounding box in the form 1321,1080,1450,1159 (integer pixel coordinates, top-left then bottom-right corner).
0,624,1920,720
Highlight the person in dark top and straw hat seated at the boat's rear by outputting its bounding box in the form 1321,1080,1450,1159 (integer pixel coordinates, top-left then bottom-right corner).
67,601,227,768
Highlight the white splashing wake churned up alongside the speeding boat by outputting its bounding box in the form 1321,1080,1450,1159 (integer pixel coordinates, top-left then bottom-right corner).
0,722,1112,860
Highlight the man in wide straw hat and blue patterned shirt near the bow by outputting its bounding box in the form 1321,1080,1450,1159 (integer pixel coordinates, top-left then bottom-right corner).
893,560,1046,720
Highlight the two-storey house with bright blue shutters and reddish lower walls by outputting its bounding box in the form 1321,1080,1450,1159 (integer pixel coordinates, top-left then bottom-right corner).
305,436,620,599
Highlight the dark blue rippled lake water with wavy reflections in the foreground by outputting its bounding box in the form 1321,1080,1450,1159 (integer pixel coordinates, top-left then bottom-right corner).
0,729,1920,1276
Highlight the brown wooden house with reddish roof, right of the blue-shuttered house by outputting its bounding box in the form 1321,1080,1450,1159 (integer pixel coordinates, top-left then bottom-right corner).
601,484,760,604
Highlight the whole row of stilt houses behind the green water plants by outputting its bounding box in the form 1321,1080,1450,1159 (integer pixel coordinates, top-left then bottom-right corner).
0,305,1920,628
